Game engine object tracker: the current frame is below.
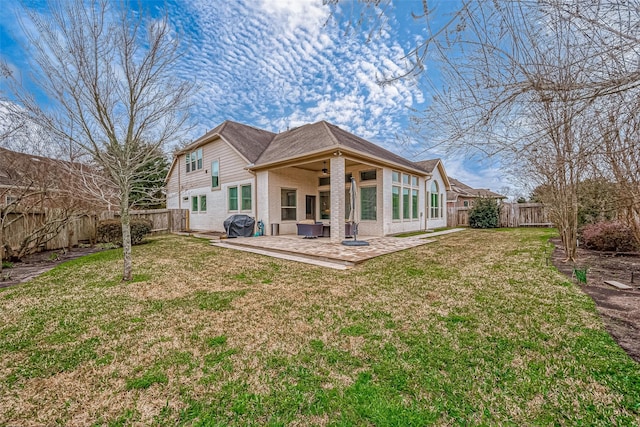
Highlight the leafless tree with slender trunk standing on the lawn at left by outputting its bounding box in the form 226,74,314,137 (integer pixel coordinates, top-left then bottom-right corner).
8,0,193,280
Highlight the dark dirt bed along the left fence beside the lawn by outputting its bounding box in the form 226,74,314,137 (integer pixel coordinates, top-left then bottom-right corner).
0,247,102,288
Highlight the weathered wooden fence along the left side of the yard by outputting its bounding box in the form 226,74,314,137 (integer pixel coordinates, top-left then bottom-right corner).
3,209,189,258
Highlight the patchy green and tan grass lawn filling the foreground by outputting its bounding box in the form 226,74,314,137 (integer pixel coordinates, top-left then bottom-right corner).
0,229,640,426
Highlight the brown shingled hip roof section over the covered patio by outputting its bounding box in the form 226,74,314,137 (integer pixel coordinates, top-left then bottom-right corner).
255,120,422,171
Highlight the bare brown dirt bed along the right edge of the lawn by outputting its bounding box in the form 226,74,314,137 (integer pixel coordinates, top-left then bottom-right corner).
551,238,640,362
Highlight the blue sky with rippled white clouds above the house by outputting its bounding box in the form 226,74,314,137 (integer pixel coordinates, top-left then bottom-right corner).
0,0,513,196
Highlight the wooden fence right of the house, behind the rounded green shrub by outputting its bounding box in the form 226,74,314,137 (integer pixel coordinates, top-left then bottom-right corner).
447,203,553,227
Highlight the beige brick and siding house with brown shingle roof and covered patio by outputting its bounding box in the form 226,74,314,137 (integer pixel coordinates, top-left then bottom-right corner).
166,121,450,242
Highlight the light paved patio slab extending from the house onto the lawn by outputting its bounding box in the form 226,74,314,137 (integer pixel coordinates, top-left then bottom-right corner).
208,228,464,269
